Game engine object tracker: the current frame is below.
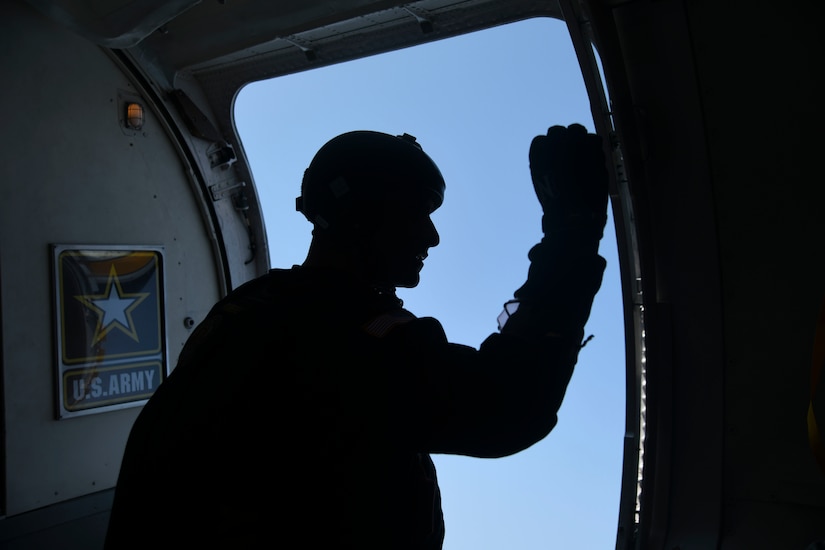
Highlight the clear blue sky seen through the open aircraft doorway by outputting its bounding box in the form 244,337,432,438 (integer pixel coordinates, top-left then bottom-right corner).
236,18,625,550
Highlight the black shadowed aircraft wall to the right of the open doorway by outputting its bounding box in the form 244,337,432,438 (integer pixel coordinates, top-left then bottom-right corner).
591,1,825,550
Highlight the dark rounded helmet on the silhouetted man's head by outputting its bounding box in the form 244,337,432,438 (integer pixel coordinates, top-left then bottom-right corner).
295,130,446,229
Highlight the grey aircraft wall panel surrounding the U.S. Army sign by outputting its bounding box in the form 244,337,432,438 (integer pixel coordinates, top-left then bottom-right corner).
0,3,223,542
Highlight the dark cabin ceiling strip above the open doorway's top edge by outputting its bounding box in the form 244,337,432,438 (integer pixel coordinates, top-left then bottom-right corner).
29,0,561,88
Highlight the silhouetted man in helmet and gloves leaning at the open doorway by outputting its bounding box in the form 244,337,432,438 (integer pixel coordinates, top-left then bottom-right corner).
107,125,607,550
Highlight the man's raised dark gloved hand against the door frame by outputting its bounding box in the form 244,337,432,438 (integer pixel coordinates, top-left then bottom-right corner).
530,124,608,240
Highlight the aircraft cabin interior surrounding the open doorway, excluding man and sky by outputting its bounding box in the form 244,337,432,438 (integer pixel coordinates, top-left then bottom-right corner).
0,0,825,550
